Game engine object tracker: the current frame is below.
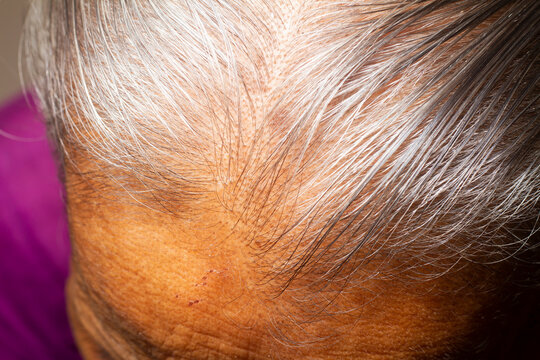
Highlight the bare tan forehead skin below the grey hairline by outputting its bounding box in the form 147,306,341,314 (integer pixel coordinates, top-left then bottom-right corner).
67,167,506,359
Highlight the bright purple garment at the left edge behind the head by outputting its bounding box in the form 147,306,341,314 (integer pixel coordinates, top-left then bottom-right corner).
0,96,80,360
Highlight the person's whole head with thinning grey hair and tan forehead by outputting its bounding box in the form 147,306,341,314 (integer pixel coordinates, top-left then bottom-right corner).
26,0,540,359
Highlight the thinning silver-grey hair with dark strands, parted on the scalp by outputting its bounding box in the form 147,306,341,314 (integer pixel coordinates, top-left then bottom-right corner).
25,0,540,286
